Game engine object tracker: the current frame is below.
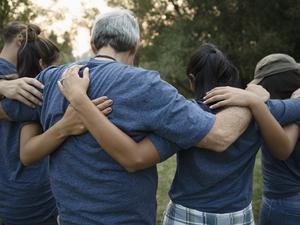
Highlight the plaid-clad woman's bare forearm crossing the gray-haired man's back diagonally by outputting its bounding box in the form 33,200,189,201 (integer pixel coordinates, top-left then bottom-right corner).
71,96,159,172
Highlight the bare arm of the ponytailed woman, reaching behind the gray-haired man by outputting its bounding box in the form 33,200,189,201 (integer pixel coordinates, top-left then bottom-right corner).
20,97,111,166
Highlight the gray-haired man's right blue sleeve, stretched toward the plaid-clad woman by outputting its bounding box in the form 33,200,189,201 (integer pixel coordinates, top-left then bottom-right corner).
136,72,216,149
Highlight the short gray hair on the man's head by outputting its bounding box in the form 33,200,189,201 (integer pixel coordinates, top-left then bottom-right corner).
91,9,140,52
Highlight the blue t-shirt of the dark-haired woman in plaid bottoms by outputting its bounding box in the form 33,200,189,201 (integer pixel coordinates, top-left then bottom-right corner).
150,100,300,213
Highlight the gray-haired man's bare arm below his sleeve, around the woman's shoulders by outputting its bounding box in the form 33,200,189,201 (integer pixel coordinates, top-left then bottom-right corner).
197,107,252,152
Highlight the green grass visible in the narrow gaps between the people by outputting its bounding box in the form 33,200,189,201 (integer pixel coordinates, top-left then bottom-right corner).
156,154,262,225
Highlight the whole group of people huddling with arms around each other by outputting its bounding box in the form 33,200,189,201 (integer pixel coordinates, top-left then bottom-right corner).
0,7,300,225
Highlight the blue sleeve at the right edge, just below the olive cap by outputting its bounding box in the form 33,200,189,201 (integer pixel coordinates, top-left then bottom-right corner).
267,99,300,125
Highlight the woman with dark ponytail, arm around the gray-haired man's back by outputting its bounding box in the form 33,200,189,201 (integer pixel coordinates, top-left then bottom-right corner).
0,25,109,225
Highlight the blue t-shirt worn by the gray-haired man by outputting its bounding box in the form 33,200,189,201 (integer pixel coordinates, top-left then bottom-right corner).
2,59,215,225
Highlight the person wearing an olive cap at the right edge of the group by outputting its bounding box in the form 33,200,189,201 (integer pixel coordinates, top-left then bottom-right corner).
251,54,300,225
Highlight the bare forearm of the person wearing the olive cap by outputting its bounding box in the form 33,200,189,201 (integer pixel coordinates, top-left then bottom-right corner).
251,102,293,160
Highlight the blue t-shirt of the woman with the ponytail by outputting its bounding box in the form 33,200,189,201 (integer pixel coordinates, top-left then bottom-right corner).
0,59,57,225
